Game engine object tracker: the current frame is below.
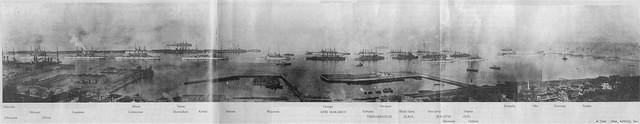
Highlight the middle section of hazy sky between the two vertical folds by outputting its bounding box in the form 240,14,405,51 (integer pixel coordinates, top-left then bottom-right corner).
218,0,439,50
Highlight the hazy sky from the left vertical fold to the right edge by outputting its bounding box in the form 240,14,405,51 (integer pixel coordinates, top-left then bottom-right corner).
218,0,640,52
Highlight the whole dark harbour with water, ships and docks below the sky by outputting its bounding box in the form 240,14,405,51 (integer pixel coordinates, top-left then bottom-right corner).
3,50,640,102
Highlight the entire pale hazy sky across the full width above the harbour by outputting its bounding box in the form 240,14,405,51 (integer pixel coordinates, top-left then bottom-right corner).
0,0,640,53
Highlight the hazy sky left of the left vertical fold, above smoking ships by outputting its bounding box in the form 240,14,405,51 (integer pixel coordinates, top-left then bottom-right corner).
0,1,211,50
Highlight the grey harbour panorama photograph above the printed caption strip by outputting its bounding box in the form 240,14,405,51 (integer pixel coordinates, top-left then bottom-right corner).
0,0,640,103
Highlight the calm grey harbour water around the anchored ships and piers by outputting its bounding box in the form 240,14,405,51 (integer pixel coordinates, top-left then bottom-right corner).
36,52,640,99
